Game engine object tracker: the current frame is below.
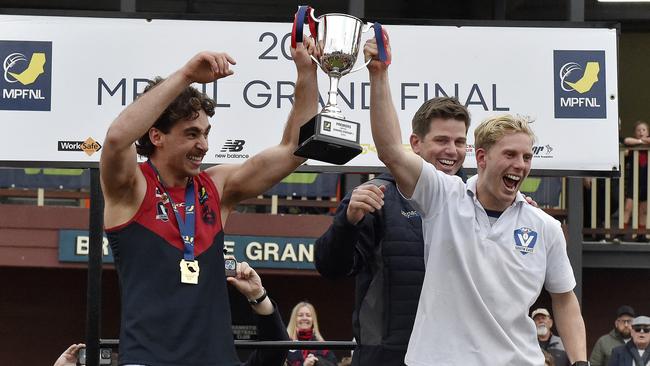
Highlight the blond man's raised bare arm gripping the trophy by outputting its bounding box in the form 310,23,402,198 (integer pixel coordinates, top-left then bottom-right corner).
363,32,422,197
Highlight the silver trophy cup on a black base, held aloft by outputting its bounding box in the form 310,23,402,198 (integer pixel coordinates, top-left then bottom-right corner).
294,14,372,164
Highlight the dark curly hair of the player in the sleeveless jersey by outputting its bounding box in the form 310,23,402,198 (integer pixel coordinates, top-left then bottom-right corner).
135,76,215,157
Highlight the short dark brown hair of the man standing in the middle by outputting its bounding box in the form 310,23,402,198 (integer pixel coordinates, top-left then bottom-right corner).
411,97,470,138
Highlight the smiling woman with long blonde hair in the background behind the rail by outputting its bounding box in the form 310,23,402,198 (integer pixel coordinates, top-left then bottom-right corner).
287,301,337,366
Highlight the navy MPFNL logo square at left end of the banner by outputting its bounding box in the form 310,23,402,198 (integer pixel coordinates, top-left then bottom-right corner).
0,41,52,111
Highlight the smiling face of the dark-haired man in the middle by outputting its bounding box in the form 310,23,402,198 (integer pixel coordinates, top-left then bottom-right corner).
410,118,467,175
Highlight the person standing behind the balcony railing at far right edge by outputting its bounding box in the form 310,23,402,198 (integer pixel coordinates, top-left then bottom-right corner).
623,121,650,234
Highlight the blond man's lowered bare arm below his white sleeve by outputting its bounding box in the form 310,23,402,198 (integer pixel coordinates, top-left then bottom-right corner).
551,291,587,363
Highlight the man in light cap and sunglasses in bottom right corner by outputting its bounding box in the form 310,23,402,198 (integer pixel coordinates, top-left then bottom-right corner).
607,316,650,366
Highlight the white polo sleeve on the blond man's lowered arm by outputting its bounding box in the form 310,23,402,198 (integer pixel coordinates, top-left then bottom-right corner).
544,220,576,294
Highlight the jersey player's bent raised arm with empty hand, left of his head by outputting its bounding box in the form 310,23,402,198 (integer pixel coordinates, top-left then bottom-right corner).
99,52,235,224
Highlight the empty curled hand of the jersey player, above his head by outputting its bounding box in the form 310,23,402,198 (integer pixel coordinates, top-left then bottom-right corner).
180,51,237,83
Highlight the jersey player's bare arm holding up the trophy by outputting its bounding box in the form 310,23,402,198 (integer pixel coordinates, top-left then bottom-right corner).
207,39,318,214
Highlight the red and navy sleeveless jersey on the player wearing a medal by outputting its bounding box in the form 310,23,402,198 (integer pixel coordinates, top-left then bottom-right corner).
106,164,240,366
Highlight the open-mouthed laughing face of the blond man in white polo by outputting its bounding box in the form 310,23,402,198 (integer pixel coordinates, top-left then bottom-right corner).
476,132,533,211
